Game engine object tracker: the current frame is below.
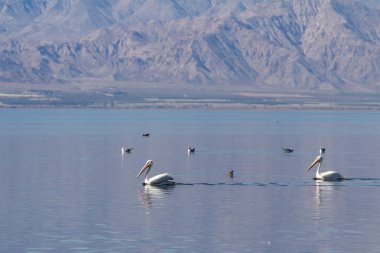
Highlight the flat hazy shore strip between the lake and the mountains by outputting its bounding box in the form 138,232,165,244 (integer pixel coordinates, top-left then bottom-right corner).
0,85,380,110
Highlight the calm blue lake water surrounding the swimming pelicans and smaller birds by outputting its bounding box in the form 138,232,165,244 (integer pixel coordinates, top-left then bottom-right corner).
0,109,380,253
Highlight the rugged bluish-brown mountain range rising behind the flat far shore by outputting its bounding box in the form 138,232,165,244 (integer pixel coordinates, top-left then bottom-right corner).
0,0,380,92
